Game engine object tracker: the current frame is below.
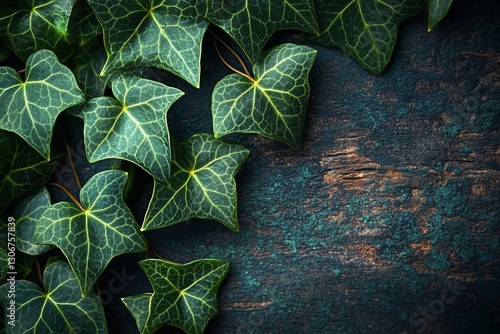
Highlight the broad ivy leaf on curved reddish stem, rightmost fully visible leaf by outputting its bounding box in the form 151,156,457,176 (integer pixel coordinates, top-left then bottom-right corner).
212,44,317,148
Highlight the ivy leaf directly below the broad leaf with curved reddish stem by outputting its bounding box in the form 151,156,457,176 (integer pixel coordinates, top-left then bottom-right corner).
142,133,249,231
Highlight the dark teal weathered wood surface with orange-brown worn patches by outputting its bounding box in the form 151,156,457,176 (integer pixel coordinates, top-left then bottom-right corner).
99,0,500,333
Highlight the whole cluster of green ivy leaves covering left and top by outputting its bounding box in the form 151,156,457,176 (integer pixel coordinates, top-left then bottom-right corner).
0,0,452,333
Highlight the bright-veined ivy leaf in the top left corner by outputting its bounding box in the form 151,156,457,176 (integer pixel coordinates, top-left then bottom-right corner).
0,0,74,61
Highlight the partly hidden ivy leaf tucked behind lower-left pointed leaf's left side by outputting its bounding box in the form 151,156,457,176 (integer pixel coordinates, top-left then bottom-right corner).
11,187,53,255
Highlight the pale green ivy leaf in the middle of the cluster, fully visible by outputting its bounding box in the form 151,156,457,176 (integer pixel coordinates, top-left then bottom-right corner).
82,72,184,183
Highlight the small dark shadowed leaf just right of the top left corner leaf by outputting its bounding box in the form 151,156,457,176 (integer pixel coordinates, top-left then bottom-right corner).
69,0,102,46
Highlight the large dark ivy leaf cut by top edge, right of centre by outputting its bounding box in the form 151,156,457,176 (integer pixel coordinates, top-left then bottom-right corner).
308,0,425,73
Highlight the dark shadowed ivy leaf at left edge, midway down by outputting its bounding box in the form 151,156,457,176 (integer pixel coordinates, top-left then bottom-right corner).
0,130,63,213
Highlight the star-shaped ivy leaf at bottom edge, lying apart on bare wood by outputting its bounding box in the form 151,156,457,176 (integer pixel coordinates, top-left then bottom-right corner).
123,259,229,334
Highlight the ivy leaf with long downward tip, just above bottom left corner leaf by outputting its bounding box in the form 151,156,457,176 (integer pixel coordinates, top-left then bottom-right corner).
35,171,147,296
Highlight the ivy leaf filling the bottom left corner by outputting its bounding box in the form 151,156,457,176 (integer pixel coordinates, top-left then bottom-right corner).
0,261,107,334
